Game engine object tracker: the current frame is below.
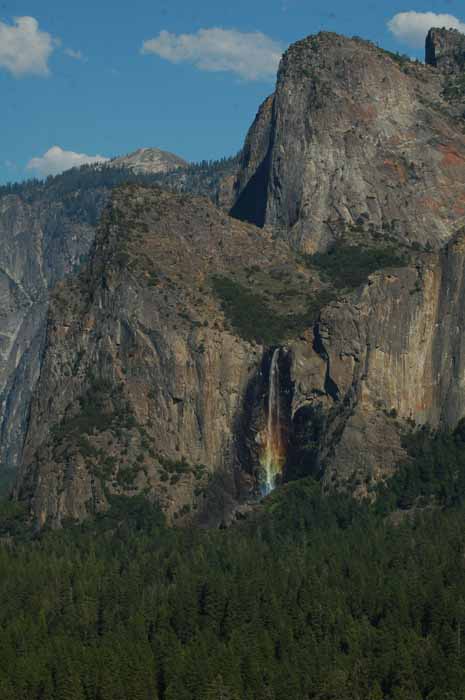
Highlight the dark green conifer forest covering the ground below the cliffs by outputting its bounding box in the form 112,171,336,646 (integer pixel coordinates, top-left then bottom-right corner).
0,430,465,700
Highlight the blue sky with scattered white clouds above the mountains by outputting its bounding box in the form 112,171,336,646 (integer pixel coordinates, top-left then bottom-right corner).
0,0,465,182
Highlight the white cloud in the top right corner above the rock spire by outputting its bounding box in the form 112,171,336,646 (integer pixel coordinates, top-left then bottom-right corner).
388,10,465,49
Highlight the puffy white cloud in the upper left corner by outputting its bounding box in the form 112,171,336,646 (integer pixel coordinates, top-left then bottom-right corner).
0,17,59,78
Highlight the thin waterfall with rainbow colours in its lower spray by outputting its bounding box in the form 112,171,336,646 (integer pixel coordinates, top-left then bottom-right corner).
260,348,285,495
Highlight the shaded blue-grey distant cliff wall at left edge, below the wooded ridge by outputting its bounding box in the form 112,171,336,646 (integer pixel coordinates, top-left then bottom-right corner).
0,190,105,490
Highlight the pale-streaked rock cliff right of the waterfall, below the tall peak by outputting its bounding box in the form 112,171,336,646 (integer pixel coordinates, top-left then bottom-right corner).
291,229,465,495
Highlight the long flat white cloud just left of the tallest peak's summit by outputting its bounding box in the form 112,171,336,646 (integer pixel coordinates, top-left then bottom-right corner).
141,28,283,80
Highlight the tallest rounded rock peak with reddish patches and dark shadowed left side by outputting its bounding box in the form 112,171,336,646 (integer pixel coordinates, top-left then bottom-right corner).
233,33,465,252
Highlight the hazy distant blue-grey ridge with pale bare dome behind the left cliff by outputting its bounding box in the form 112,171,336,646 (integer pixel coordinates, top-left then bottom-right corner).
0,149,234,489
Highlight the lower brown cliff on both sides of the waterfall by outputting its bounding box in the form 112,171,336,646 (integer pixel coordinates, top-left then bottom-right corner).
17,188,465,525
